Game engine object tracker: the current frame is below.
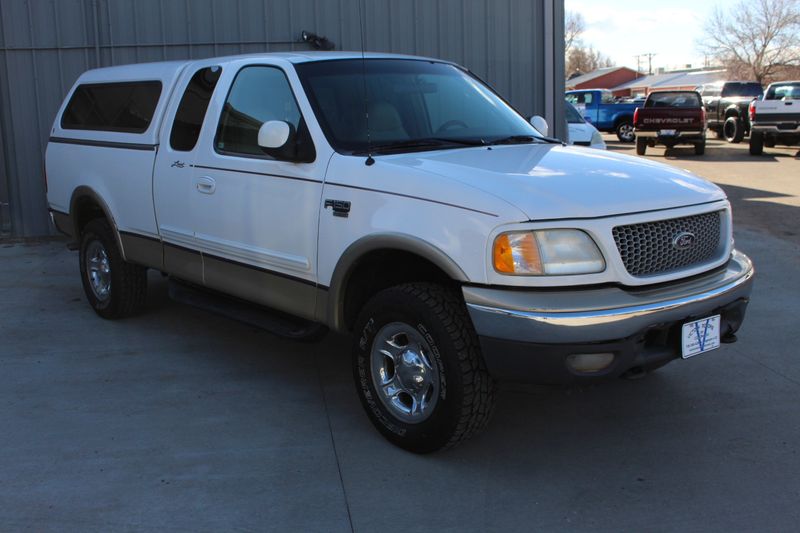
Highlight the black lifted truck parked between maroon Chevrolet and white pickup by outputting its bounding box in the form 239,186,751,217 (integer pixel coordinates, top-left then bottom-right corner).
697,81,764,143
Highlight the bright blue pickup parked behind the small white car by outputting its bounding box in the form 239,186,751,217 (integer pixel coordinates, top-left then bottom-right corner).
565,89,643,142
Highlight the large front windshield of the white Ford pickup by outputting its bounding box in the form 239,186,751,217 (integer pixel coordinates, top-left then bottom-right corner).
295,59,542,154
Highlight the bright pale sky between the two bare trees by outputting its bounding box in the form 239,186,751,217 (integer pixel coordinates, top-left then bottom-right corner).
564,0,730,72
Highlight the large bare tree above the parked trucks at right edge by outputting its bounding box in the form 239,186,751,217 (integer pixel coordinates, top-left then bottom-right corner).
700,0,800,83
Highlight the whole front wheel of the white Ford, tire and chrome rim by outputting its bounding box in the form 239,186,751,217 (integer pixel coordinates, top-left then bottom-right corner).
353,283,495,453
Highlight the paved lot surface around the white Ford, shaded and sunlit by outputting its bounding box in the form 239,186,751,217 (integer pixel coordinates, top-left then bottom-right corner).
0,137,800,532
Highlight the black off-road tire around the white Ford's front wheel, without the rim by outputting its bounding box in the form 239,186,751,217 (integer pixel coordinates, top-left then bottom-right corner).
352,283,495,453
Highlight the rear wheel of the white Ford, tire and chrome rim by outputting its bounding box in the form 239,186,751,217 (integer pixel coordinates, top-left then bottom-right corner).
80,218,147,318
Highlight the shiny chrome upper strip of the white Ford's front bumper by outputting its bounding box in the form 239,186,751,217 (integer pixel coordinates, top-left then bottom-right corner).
467,256,755,327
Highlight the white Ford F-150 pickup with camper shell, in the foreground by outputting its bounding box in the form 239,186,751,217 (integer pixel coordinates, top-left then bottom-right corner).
46,52,754,452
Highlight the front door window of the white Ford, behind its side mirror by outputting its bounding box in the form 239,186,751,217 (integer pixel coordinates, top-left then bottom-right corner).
215,66,302,157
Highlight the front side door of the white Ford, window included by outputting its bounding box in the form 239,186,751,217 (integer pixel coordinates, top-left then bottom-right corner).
191,64,327,318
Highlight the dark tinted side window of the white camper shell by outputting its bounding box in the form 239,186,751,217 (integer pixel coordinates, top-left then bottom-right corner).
61,81,161,133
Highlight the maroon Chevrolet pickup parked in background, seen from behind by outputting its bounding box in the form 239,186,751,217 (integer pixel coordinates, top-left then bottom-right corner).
633,91,706,155
